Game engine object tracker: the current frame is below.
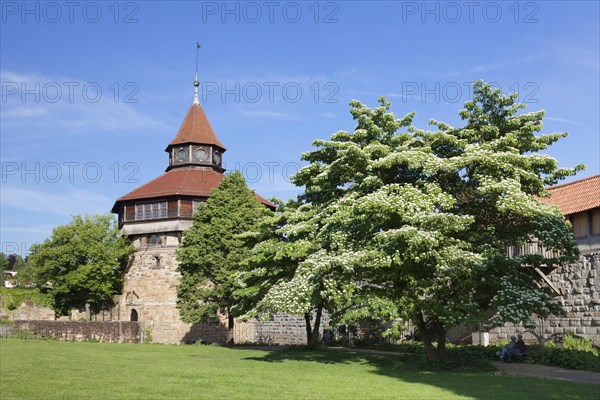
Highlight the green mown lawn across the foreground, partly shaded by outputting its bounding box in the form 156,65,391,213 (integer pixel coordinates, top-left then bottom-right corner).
0,339,600,400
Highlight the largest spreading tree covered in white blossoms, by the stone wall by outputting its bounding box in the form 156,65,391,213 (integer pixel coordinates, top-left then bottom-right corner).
245,82,582,359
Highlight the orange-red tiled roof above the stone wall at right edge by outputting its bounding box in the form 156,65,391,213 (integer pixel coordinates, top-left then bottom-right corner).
540,175,600,215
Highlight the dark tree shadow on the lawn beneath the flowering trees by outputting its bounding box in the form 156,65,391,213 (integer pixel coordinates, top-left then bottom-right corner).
244,348,600,400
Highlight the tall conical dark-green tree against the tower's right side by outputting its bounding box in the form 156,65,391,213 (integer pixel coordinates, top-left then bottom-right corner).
177,171,271,341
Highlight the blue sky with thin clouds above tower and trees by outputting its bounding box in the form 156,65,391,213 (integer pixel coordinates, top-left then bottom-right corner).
0,1,600,255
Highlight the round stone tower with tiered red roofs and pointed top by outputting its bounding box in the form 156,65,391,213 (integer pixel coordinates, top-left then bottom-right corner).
112,70,275,343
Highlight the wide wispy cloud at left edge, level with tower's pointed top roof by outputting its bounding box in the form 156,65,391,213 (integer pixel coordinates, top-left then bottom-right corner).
0,70,171,138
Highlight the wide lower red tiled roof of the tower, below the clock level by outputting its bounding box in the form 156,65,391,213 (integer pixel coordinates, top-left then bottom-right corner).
112,168,276,213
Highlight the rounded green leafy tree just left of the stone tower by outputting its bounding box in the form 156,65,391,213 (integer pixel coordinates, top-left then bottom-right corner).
28,214,133,315
